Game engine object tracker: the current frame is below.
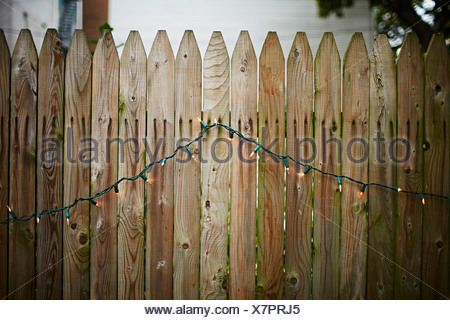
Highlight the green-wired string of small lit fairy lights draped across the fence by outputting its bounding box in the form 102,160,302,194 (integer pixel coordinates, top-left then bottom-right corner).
0,118,450,226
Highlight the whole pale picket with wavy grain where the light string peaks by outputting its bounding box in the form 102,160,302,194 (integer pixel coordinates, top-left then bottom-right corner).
200,31,232,300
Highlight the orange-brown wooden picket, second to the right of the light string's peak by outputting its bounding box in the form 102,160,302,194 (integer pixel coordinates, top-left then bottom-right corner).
256,32,285,299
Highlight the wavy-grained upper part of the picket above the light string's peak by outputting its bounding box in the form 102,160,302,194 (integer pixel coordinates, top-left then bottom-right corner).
203,31,230,114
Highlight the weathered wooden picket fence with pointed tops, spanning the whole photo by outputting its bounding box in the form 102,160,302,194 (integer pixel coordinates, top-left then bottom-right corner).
0,29,450,299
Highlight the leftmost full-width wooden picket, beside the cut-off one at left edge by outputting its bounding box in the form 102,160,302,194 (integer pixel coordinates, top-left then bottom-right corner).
8,29,38,300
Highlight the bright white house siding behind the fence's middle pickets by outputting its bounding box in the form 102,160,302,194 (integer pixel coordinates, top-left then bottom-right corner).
109,0,375,57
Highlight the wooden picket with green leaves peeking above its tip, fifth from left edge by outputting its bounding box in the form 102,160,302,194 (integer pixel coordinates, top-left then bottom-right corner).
91,30,119,299
